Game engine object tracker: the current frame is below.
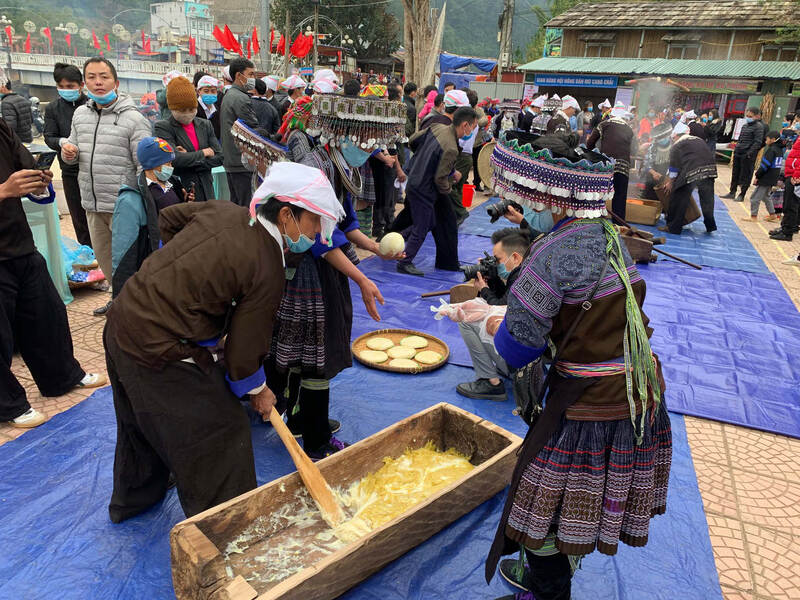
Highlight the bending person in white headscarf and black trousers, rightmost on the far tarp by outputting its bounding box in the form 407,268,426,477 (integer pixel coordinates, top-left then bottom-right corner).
659,123,717,235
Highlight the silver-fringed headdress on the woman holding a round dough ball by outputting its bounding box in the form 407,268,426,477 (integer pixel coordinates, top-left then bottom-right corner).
307,94,407,151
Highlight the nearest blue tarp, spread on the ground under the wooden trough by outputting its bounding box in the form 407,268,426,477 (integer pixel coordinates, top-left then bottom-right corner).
0,365,722,600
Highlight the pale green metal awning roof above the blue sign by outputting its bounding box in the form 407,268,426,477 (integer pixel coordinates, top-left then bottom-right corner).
519,57,800,80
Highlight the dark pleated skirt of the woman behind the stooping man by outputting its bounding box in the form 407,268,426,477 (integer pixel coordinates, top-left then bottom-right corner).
269,252,325,377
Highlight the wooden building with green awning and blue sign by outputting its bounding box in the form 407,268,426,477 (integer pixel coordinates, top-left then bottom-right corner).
520,0,800,132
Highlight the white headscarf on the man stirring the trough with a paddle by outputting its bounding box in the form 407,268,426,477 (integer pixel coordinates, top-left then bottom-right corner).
250,162,345,246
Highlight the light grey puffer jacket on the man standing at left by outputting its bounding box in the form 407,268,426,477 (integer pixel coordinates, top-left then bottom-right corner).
61,94,152,213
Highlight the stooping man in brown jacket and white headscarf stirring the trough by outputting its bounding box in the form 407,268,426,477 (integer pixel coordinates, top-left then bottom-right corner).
103,163,343,523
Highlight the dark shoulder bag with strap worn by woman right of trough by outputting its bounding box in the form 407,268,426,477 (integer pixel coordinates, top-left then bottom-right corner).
512,254,610,427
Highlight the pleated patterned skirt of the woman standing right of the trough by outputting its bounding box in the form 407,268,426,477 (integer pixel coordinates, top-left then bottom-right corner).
506,403,672,555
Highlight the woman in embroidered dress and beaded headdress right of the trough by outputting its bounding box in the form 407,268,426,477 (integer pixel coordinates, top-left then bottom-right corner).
486,134,672,600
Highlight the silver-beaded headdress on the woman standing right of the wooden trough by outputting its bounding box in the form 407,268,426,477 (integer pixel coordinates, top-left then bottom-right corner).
491,137,614,218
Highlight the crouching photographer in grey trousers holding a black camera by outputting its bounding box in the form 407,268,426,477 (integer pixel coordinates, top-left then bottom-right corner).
456,227,530,401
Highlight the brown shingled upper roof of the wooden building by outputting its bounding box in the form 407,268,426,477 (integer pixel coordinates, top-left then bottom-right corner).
547,0,797,29
